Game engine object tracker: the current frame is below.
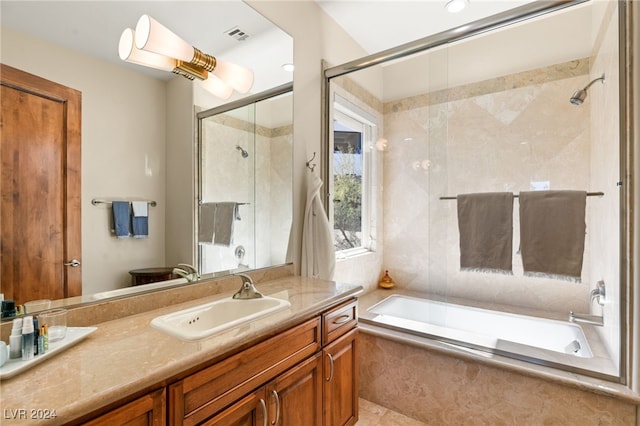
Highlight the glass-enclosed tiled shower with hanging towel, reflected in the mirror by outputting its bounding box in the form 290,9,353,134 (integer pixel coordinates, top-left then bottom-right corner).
198,84,293,274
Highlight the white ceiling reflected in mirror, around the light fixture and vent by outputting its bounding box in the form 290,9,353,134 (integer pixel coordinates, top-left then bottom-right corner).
0,0,293,93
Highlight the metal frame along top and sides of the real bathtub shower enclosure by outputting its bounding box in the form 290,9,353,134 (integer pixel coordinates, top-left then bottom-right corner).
320,0,640,386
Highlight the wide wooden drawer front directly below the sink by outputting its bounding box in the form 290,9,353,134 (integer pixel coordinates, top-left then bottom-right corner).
169,317,320,425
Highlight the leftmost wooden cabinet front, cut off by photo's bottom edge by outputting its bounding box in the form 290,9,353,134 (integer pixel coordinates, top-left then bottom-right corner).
85,388,167,426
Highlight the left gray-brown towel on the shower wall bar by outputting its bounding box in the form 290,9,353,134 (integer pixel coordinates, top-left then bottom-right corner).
457,192,513,274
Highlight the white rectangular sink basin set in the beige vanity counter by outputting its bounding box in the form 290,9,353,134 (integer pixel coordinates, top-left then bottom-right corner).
151,296,291,341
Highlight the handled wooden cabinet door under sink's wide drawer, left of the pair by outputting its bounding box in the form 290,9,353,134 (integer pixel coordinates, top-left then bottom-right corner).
203,387,267,426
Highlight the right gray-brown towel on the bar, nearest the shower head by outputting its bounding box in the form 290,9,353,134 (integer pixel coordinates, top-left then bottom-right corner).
520,191,587,282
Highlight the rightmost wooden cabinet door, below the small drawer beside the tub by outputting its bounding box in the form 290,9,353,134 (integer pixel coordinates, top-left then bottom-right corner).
322,329,358,426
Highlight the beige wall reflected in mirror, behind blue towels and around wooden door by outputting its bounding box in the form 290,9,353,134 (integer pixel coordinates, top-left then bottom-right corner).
0,27,166,293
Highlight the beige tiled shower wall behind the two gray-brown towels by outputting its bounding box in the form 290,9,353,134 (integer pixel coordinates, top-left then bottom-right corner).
384,58,601,314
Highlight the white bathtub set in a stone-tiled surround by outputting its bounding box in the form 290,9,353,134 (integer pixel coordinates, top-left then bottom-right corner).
364,294,593,359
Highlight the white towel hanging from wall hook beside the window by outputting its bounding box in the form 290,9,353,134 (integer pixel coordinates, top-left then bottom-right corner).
301,173,336,280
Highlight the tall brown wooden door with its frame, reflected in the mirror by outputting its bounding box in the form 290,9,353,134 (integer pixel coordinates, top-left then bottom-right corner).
0,64,82,304
